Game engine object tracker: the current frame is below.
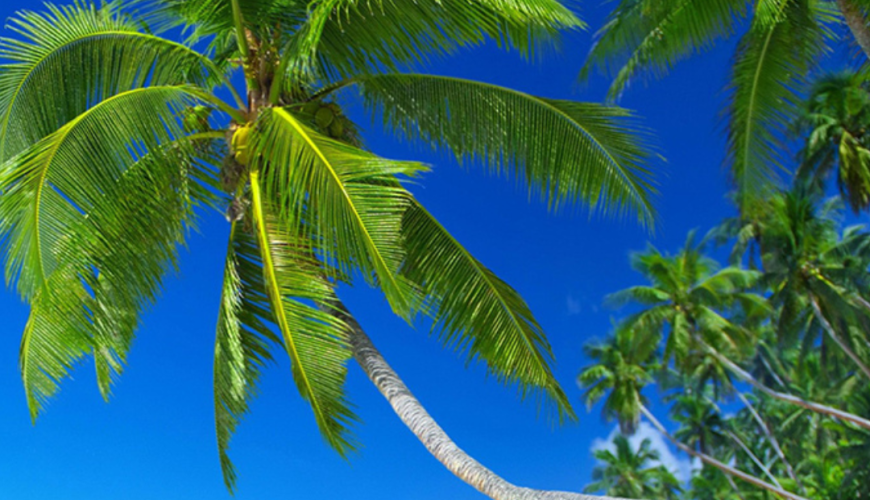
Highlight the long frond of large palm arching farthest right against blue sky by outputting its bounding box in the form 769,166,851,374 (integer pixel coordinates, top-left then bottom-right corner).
356,75,654,224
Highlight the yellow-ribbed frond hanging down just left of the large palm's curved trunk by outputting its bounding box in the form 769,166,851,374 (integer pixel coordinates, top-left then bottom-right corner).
244,171,357,456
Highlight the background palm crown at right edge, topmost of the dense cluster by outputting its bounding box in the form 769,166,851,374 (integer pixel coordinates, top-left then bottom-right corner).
759,189,870,378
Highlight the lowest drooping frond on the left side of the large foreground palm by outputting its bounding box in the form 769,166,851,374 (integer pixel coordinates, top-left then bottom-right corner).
20,131,212,419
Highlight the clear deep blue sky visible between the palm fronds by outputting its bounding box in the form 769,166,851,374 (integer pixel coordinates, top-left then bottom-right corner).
0,0,733,500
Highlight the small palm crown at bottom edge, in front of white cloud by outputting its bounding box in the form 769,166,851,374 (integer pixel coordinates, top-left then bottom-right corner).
584,434,682,499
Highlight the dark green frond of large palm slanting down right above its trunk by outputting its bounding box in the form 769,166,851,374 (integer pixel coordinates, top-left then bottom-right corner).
402,202,573,419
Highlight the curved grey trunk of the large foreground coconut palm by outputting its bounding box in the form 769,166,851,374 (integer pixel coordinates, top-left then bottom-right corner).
329,300,628,500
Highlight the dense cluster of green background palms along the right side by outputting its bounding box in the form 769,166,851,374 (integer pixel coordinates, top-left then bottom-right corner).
578,73,870,500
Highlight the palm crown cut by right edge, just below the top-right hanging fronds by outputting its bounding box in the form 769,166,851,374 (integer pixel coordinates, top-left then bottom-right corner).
795,71,870,213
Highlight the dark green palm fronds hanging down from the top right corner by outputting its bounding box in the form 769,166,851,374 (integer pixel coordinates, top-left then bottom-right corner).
583,0,870,212
